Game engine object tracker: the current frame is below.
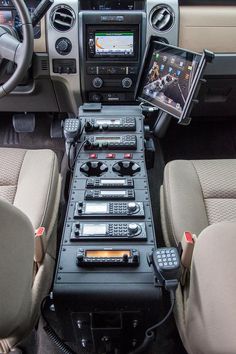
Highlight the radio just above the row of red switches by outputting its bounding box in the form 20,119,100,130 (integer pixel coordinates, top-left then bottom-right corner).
84,135,137,150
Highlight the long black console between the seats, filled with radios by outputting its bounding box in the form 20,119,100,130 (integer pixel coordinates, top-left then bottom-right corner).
53,106,163,354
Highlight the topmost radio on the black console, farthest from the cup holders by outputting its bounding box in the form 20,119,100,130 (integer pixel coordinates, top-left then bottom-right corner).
85,117,136,132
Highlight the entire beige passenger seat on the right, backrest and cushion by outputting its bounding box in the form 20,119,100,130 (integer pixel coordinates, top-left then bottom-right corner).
161,160,236,354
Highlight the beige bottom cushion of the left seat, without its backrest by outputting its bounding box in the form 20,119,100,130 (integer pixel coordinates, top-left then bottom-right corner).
0,148,59,229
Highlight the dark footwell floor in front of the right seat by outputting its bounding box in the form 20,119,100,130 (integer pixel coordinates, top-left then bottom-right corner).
160,118,236,163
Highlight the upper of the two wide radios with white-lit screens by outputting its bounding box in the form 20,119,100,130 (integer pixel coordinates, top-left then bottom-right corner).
74,202,145,219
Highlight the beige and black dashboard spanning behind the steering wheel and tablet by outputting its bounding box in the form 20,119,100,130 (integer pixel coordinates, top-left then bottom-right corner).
0,0,236,114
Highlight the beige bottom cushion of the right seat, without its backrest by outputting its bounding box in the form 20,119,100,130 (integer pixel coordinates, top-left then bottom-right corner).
161,160,236,244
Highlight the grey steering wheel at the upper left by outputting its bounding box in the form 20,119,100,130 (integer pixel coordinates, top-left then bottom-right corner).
0,0,34,98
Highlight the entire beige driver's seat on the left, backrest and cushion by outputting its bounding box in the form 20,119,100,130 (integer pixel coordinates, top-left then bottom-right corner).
0,148,60,353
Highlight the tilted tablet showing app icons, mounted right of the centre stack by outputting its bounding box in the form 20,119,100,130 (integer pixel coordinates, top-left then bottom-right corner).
139,42,201,118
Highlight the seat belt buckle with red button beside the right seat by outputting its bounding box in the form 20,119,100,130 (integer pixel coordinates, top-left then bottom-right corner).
181,231,197,286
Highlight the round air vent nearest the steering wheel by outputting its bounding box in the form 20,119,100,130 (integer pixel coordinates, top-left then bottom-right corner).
51,5,75,32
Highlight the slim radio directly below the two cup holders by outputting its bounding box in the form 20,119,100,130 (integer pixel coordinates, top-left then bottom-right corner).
86,178,134,188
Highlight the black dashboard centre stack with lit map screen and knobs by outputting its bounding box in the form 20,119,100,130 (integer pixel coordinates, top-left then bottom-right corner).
79,10,146,104
